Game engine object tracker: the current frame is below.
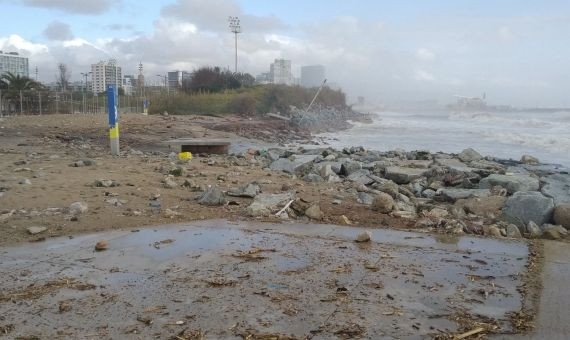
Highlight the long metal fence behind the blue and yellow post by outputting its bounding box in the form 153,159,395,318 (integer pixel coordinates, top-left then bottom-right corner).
0,90,151,117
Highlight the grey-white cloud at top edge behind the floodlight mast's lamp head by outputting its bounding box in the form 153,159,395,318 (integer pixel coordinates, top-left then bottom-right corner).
161,0,286,32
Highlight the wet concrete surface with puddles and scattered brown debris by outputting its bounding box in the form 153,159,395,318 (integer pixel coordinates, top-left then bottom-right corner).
0,220,528,339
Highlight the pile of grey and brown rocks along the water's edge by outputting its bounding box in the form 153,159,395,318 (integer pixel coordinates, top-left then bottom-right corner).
255,147,570,239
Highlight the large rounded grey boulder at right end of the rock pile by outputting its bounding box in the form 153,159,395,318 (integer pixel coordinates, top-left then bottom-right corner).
503,191,554,226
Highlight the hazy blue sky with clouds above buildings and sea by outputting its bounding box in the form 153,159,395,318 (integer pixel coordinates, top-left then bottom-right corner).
0,0,570,107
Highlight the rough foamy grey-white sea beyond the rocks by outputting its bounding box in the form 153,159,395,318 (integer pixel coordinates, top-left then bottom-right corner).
318,111,570,166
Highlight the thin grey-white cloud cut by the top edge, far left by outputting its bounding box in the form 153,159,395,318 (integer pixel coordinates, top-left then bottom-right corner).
19,0,113,14
